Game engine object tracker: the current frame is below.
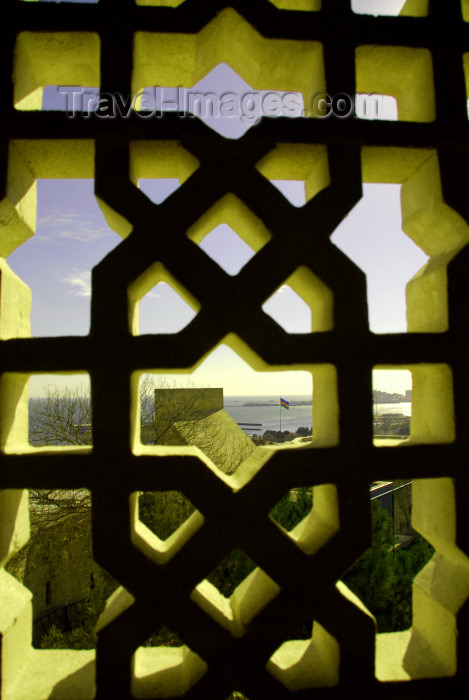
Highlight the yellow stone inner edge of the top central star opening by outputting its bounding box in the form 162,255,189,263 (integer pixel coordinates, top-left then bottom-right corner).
131,8,325,123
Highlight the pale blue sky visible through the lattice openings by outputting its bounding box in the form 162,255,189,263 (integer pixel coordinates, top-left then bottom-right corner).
8,0,414,394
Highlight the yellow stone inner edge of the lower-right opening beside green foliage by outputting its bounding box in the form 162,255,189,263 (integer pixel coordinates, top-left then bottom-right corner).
375,478,469,681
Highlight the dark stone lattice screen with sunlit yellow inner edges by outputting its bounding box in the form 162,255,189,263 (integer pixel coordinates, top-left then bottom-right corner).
0,0,469,700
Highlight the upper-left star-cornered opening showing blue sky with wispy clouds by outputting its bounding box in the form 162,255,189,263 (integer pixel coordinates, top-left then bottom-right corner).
4,178,120,337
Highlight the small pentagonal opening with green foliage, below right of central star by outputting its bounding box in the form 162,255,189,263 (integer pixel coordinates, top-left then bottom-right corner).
269,484,339,555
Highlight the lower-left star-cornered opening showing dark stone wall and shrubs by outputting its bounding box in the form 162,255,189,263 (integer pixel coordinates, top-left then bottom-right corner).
6,488,117,649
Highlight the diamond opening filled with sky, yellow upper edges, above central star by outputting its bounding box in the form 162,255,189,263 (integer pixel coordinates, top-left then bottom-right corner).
187,194,271,275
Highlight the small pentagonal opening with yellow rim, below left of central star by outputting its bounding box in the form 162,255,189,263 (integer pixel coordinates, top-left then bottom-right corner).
130,491,204,565
